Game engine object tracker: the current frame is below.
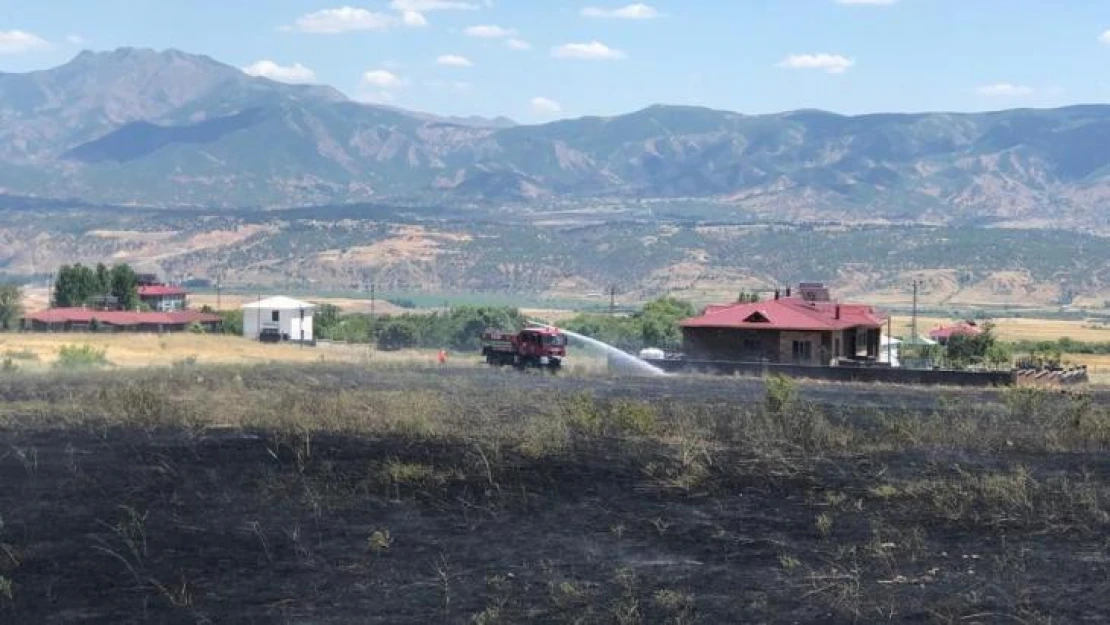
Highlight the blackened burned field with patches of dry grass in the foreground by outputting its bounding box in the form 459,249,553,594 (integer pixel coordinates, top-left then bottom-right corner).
0,365,1110,624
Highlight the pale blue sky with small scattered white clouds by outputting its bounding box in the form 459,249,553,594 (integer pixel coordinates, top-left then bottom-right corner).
0,0,1110,122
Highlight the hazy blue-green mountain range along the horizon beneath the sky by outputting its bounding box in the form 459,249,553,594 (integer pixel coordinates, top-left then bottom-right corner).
0,48,1110,231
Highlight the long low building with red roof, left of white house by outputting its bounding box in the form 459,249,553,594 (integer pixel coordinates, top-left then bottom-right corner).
23,309,223,332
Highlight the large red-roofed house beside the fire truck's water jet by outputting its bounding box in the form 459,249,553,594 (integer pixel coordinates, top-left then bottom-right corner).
680,283,886,365
